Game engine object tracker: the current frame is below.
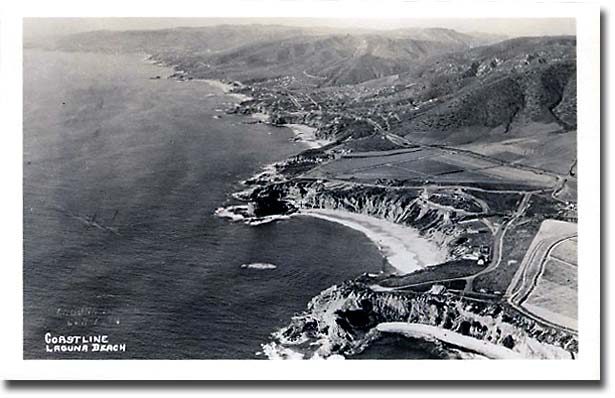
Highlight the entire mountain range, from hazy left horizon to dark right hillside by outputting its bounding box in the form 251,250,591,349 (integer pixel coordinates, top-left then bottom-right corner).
29,25,576,155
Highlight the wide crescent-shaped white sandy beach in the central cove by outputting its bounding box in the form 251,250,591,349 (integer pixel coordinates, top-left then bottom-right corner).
299,209,446,274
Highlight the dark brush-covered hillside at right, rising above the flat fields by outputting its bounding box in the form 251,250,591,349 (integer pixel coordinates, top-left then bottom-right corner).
382,37,576,143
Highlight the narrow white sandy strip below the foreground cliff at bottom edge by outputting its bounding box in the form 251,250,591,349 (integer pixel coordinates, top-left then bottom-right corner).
376,322,521,359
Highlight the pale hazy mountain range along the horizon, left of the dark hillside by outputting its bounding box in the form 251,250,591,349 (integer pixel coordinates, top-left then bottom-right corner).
28,25,502,85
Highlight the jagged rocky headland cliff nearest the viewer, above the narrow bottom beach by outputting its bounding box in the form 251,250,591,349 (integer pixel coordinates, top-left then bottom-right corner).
264,280,578,359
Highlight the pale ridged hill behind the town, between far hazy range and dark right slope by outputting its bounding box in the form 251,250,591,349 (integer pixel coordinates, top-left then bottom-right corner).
194,34,478,86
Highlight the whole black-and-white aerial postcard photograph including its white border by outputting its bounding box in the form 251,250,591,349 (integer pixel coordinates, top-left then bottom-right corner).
0,0,600,377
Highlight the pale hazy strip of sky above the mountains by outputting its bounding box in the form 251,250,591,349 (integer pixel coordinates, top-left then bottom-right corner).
24,18,576,39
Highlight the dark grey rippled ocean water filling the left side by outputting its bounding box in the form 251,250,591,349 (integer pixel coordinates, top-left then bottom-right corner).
23,49,438,359
